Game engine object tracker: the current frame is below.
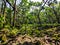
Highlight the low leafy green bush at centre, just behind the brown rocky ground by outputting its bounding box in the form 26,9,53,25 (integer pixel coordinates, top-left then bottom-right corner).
20,24,33,34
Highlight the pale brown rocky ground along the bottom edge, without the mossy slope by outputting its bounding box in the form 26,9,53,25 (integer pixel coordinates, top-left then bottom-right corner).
1,35,60,45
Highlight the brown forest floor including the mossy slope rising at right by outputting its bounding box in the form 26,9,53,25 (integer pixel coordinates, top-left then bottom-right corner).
0,27,60,45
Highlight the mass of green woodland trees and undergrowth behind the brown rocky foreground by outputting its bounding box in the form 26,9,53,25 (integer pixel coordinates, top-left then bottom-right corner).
0,0,60,42
